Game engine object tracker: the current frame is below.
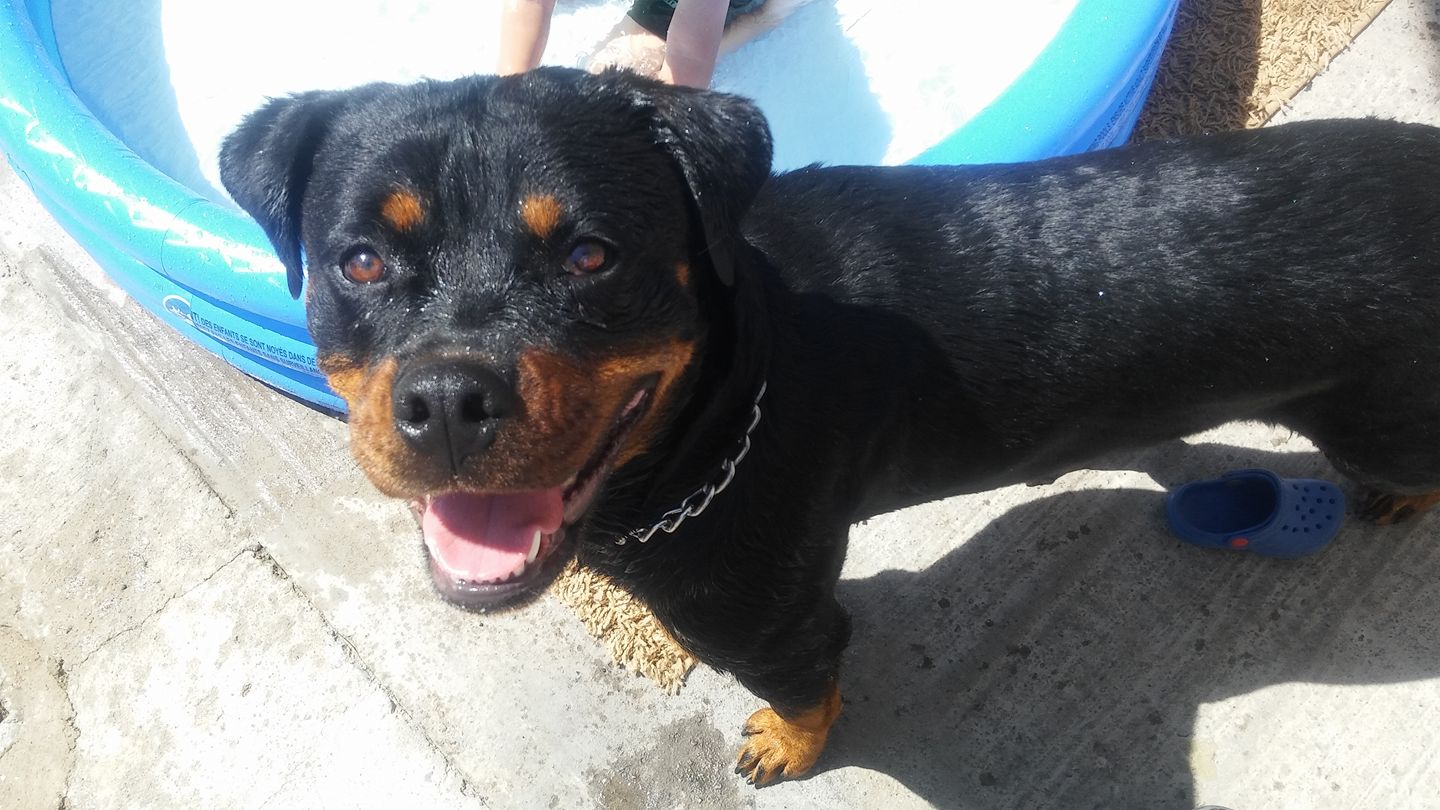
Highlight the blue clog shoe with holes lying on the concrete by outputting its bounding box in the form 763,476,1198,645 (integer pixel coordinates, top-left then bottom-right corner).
1165,470,1345,558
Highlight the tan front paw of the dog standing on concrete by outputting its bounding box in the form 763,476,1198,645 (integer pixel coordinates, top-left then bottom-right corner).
734,687,840,787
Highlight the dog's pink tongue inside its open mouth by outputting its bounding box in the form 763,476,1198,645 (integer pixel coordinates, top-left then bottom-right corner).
420,487,564,582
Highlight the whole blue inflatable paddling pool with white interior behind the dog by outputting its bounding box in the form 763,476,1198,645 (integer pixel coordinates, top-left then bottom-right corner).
0,0,1179,411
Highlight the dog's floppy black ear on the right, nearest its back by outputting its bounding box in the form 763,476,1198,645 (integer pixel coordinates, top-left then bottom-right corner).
622,75,770,285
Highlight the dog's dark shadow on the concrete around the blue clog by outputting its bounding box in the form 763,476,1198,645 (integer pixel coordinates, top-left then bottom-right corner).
825,445,1440,809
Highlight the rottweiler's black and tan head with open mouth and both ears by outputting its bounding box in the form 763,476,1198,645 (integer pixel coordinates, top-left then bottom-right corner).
220,69,770,607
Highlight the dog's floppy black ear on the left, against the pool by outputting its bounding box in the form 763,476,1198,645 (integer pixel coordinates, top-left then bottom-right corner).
220,91,348,298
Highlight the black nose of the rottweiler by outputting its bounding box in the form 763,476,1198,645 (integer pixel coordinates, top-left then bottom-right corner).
392,360,516,473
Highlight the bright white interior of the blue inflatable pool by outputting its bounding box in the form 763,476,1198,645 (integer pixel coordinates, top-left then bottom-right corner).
53,0,1080,200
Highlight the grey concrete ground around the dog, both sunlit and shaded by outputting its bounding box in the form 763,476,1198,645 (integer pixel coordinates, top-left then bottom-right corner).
0,0,1440,810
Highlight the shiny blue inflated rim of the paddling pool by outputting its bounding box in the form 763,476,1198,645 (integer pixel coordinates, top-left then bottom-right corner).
0,0,1179,411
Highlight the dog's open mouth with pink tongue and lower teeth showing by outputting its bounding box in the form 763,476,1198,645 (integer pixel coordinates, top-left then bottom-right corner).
415,385,654,610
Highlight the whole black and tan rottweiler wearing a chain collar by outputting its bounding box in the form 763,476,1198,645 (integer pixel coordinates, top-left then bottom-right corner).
222,69,1440,783
